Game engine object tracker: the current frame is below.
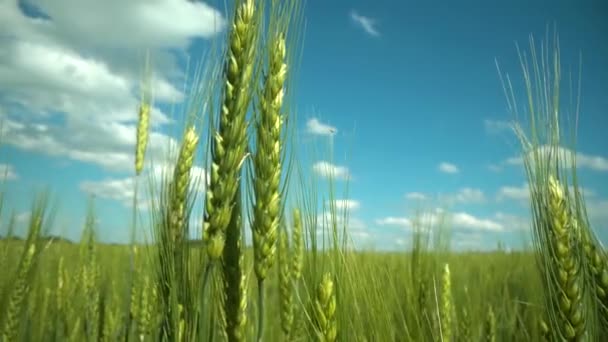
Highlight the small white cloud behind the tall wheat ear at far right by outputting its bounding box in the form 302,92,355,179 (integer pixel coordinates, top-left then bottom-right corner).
505,145,608,171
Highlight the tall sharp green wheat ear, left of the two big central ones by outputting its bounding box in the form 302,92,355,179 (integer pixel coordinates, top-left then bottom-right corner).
203,0,259,261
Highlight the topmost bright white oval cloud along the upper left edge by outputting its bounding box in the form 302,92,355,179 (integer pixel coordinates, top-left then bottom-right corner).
0,0,225,49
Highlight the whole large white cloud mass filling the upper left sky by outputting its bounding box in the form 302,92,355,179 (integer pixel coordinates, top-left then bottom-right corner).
0,0,225,172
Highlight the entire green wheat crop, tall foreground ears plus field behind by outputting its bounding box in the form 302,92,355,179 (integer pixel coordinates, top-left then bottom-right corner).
0,0,608,341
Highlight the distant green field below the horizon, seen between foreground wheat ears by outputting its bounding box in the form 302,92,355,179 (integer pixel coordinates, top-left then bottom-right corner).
0,236,542,341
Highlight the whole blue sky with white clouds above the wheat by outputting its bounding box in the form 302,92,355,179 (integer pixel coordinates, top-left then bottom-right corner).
0,0,608,249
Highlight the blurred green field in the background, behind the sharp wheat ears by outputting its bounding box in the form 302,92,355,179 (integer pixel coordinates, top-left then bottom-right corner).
0,236,542,341
